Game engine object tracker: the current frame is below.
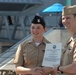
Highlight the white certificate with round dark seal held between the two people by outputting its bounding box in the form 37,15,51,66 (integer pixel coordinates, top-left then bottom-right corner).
42,43,62,67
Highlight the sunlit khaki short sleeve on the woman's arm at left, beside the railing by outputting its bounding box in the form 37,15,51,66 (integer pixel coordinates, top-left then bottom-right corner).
14,45,23,65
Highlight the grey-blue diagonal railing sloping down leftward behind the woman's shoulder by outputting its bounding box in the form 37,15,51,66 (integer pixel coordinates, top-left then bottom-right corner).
0,35,31,69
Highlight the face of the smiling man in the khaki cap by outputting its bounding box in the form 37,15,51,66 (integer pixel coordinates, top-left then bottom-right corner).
62,15,76,30
